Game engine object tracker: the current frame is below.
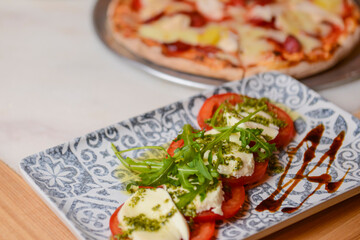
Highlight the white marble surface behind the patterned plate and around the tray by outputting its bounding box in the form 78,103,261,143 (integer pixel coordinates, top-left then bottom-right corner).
0,0,360,171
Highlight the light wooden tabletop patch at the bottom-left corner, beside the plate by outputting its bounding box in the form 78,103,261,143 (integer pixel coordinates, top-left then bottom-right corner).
0,161,76,240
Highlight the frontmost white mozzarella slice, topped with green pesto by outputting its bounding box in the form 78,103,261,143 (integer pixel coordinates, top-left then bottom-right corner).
117,188,189,240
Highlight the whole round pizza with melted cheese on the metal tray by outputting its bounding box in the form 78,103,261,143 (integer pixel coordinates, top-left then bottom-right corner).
107,0,360,81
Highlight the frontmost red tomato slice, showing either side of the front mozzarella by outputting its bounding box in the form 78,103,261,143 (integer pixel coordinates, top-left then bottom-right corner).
109,205,215,240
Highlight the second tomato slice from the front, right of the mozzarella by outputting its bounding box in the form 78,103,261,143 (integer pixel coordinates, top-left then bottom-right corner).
194,186,245,222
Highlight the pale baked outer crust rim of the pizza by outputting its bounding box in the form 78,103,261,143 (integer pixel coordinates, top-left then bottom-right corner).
107,0,360,81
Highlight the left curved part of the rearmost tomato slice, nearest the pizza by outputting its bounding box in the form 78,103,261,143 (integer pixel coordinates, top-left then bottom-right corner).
197,93,243,131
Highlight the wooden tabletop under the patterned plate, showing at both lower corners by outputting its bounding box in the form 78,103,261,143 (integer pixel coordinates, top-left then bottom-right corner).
0,112,360,240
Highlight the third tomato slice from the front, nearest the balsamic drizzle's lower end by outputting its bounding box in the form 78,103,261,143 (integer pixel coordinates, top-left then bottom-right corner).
221,160,269,186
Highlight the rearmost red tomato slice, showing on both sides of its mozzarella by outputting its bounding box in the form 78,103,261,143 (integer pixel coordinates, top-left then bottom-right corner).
197,93,295,148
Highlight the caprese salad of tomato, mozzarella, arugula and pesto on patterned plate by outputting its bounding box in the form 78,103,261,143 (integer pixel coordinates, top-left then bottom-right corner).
110,93,295,240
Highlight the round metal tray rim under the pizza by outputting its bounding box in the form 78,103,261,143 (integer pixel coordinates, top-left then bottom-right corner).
93,0,360,90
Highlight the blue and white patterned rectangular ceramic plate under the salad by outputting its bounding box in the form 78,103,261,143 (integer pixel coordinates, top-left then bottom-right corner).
20,72,360,240
